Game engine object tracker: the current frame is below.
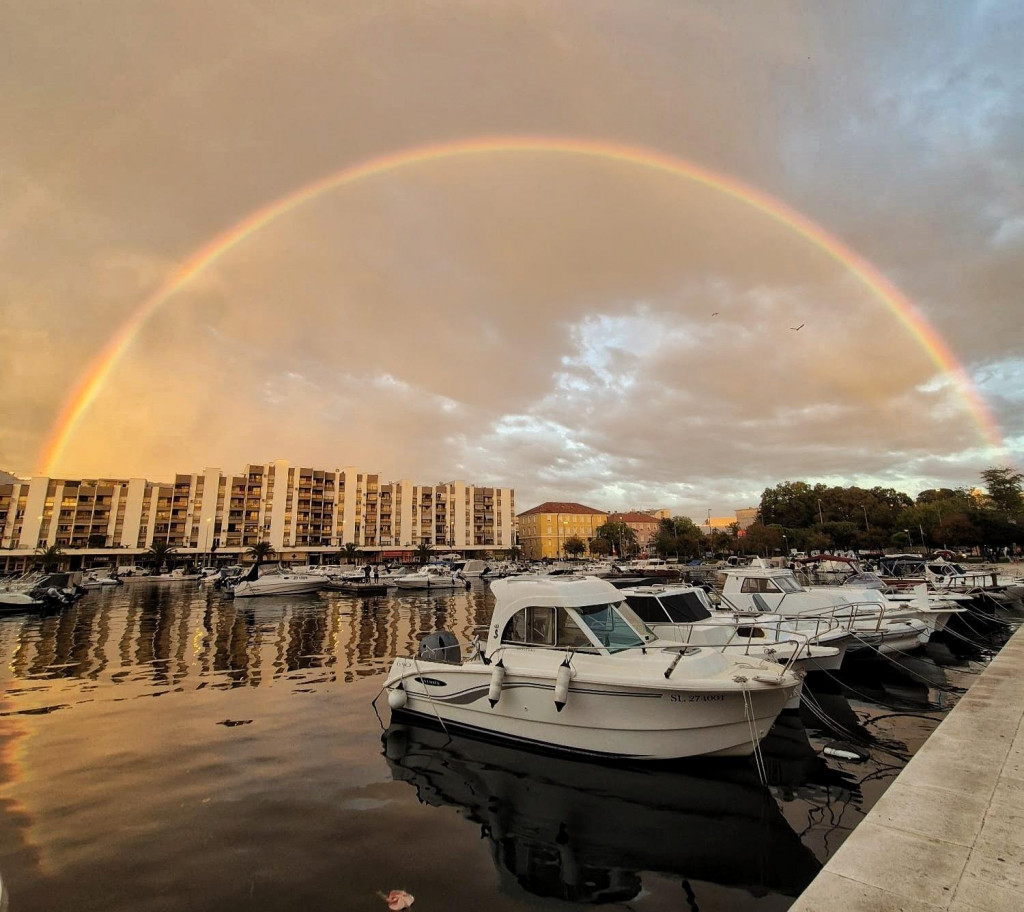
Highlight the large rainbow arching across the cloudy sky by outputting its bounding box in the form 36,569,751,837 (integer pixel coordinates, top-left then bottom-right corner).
40,136,1005,475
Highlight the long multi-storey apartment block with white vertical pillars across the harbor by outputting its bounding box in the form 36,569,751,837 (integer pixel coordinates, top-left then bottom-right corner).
0,460,515,571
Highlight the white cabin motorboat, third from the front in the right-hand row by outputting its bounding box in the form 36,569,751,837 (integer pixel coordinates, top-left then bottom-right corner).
722,566,931,655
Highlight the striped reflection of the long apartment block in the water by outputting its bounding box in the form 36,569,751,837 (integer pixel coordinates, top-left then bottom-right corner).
6,583,492,687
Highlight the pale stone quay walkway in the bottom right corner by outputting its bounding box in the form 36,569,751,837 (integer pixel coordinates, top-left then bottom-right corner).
791,627,1024,912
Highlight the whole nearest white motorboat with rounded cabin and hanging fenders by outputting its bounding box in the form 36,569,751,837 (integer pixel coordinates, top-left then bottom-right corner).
384,577,800,759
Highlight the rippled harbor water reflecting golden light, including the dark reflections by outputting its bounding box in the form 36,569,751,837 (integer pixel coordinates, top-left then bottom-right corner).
0,581,1006,912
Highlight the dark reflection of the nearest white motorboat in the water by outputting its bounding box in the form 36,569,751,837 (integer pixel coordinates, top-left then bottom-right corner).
383,723,820,903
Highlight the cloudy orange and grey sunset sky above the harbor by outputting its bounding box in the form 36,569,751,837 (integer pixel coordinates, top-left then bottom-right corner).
0,0,1024,517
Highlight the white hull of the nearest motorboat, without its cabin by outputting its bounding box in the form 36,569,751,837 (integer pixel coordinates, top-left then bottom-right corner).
387,658,796,761
